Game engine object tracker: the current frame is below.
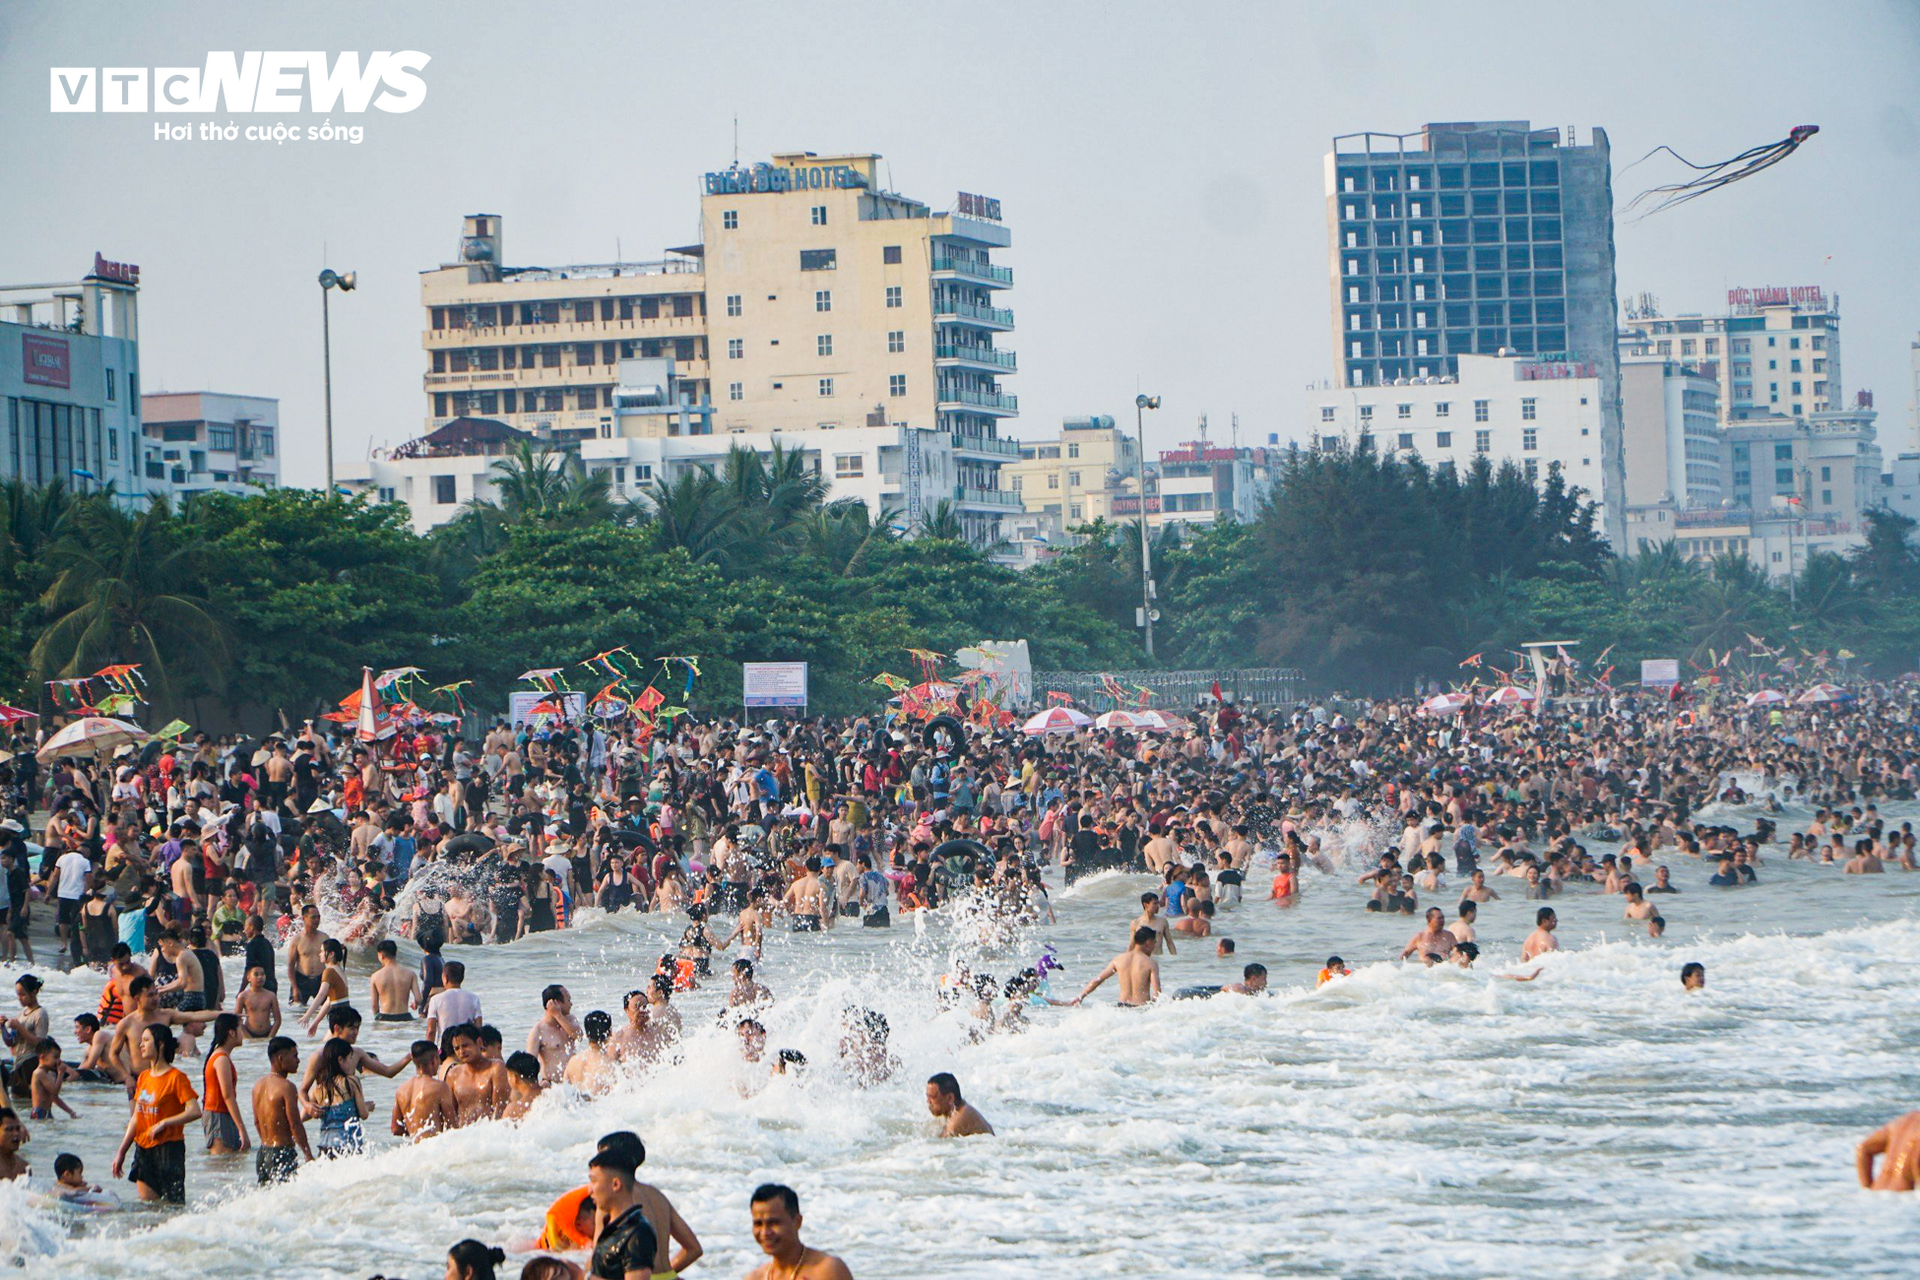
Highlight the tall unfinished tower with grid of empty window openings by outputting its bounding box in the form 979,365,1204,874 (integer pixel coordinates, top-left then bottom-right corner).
1325,121,1624,545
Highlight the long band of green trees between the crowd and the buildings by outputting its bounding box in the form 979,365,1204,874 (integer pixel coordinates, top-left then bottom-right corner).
0,441,1920,727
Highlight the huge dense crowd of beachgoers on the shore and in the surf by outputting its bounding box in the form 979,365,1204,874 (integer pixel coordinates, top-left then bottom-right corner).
0,685,1920,1276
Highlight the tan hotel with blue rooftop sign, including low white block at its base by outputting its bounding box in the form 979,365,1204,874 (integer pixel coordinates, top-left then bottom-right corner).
360,152,1020,541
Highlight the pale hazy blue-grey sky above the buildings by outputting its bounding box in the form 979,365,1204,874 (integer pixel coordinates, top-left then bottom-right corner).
11,0,1920,484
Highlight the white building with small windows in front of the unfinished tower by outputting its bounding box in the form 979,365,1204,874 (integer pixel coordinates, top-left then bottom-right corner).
1306,355,1626,547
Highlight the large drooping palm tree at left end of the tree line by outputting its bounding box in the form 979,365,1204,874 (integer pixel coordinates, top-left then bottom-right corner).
29,497,227,704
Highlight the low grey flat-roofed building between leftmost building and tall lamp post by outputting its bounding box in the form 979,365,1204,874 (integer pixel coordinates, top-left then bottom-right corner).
140,391,280,499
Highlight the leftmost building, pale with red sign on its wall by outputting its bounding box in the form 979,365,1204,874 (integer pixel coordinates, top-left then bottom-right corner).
0,253,146,503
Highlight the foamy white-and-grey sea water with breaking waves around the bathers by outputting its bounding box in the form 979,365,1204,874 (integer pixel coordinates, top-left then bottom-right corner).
0,806,1920,1280
